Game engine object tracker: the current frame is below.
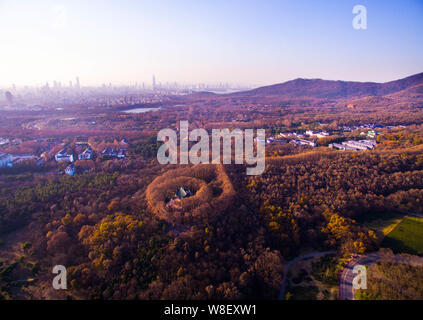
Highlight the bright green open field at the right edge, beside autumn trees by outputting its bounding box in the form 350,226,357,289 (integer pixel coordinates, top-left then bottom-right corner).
382,217,423,254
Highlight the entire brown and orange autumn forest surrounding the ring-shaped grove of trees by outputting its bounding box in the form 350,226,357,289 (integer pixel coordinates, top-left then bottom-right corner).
0,84,423,299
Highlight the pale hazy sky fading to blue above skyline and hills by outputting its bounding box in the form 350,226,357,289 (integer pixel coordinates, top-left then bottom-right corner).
0,0,423,86
